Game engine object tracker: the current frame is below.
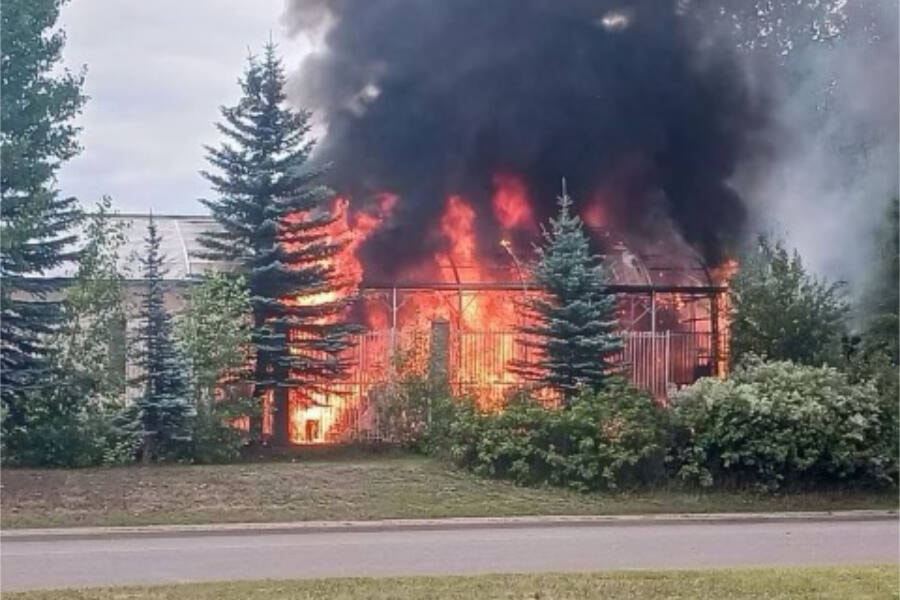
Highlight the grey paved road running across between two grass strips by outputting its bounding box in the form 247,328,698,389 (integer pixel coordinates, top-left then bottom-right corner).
0,519,900,591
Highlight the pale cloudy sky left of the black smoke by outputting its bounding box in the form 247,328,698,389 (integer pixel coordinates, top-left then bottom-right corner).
59,0,312,214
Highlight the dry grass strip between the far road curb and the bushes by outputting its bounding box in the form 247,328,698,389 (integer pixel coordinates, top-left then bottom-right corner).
0,458,898,528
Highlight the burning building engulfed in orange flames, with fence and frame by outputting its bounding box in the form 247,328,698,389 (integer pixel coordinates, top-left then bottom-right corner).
278,180,733,443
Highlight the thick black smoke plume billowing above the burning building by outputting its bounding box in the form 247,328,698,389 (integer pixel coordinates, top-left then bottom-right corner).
287,0,764,278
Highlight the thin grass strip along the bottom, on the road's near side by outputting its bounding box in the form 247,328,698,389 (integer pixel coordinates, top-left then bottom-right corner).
3,565,900,600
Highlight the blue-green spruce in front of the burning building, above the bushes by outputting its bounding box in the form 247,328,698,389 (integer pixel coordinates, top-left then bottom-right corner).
512,182,622,403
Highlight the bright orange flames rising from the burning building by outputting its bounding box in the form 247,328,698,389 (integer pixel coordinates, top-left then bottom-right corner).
270,173,737,443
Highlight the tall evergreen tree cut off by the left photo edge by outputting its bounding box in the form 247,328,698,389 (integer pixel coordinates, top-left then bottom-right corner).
0,0,85,431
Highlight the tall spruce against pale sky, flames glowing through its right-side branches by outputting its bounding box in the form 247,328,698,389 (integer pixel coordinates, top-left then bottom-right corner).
199,43,355,444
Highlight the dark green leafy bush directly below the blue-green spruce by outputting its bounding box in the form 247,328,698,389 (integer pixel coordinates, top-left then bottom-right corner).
449,386,666,490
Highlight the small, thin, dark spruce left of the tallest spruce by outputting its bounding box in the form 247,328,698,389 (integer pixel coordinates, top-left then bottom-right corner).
129,215,194,462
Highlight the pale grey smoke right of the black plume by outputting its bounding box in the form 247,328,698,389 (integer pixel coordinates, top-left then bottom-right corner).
735,0,900,293
